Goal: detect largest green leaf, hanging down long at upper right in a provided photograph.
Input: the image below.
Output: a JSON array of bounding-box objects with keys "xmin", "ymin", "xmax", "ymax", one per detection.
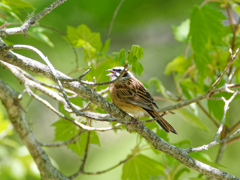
[{"xmin": 190, "ymin": 5, "xmax": 226, "ymax": 79}]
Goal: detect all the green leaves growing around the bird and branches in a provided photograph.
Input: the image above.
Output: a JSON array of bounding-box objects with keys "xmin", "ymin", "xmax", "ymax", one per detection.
[{"xmin": 0, "ymin": 0, "xmax": 240, "ymax": 180}]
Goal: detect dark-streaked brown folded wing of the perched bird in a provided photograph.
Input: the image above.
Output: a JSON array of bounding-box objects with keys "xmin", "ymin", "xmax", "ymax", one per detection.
[{"xmin": 115, "ymin": 78, "xmax": 158, "ymax": 110}]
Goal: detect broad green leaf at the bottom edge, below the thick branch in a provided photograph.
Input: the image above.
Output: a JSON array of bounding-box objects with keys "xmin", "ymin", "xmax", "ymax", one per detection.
[{"xmin": 122, "ymin": 154, "xmax": 164, "ymax": 180}]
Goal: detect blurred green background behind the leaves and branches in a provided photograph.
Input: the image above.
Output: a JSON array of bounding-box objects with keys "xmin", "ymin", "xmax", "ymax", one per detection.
[{"xmin": 0, "ymin": 0, "xmax": 240, "ymax": 180}]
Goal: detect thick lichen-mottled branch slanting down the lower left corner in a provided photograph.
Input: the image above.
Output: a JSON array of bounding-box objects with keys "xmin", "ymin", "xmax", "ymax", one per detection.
[{"xmin": 0, "ymin": 80, "xmax": 68, "ymax": 180}]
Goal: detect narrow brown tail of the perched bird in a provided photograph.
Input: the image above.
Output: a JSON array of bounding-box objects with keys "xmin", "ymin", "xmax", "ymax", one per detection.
[{"xmin": 144, "ymin": 109, "xmax": 177, "ymax": 134}]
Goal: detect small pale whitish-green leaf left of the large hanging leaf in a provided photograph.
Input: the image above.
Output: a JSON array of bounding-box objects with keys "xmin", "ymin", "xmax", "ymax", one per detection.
[{"xmin": 172, "ymin": 19, "xmax": 190, "ymax": 42}]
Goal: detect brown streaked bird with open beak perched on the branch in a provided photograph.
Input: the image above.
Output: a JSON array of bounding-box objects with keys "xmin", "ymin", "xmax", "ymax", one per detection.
[{"xmin": 106, "ymin": 66, "xmax": 177, "ymax": 134}]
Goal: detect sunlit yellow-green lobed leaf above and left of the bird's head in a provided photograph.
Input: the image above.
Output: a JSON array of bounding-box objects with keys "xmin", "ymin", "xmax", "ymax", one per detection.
[{"xmin": 67, "ymin": 24, "xmax": 102, "ymax": 50}]
